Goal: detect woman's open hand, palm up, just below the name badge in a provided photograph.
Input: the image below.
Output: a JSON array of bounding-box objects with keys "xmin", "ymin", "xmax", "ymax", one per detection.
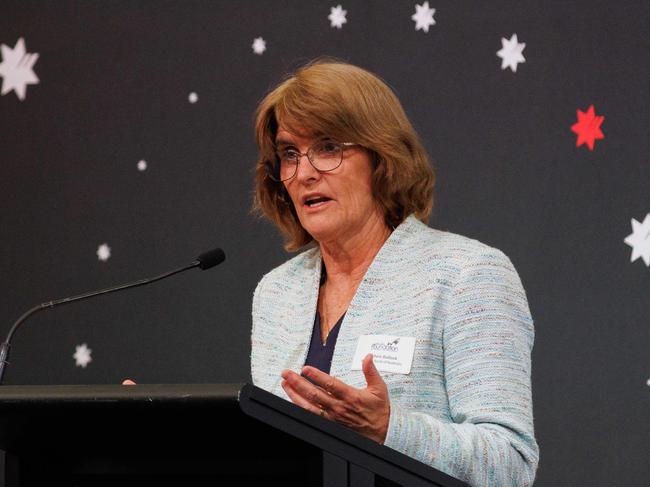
[{"xmin": 282, "ymin": 354, "xmax": 390, "ymax": 443}]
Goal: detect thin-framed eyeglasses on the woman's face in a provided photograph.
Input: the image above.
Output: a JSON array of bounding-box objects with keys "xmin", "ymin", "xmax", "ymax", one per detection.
[{"xmin": 266, "ymin": 140, "xmax": 358, "ymax": 183}]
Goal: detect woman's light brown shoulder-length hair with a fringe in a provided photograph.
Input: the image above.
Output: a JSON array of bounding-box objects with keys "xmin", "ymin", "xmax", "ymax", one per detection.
[{"xmin": 253, "ymin": 59, "xmax": 436, "ymax": 251}]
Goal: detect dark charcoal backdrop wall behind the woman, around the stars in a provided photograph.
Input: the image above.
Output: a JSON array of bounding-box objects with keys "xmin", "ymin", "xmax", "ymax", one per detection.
[{"xmin": 0, "ymin": 0, "xmax": 650, "ymax": 486}]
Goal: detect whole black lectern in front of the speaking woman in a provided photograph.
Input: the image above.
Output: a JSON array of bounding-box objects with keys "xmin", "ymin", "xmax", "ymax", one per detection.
[{"xmin": 0, "ymin": 384, "xmax": 465, "ymax": 487}]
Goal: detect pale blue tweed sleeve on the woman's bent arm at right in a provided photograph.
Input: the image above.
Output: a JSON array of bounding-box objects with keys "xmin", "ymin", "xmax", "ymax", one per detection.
[{"xmin": 384, "ymin": 248, "xmax": 539, "ymax": 487}]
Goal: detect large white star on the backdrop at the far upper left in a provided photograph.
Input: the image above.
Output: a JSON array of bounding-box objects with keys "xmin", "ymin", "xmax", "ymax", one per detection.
[{"xmin": 0, "ymin": 37, "xmax": 39, "ymax": 101}]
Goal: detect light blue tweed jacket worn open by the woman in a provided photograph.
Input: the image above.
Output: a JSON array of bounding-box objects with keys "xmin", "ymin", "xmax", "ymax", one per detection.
[{"xmin": 251, "ymin": 216, "xmax": 539, "ymax": 487}]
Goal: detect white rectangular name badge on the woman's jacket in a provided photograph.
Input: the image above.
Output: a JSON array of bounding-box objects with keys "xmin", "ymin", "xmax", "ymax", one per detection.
[{"xmin": 352, "ymin": 335, "xmax": 415, "ymax": 374}]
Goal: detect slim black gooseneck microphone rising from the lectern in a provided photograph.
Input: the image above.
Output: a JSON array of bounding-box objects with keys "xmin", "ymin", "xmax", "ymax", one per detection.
[{"xmin": 0, "ymin": 248, "xmax": 226, "ymax": 385}]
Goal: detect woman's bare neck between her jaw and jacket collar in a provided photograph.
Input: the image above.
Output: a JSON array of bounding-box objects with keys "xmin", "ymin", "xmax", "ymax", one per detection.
[{"xmin": 319, "ymin": 215, "xmax": 391, "ymax": 283}]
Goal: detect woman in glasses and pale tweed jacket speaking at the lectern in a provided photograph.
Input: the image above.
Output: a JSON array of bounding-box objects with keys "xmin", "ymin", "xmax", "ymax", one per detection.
[{"xmin": 251, "ymin": 61, "xmax": 539, "ymax": 486}]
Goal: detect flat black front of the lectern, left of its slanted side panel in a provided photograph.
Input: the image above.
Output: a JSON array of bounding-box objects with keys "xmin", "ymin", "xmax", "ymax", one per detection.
[{"xmin": 0, "ymin": 384, "xmax": 322, "ymax": 487}]
